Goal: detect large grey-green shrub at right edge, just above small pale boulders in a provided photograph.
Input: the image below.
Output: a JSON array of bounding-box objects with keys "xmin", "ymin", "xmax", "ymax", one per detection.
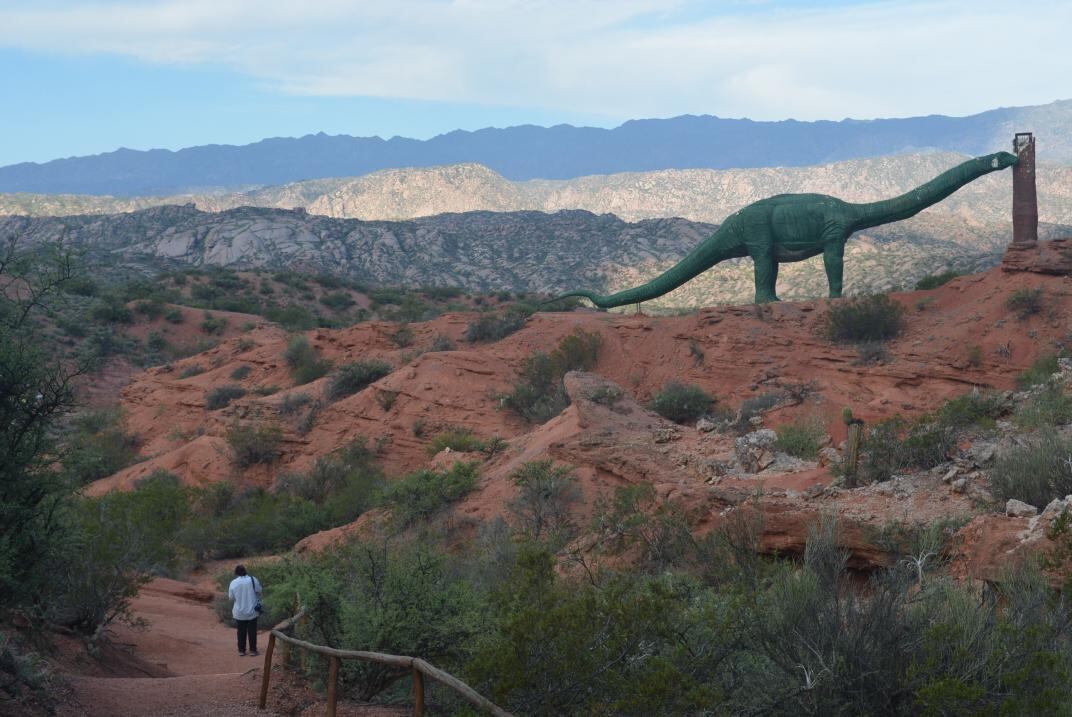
[{"xmin": 991, "ymin": 431, "xmax": 1072, "ymax": 510}]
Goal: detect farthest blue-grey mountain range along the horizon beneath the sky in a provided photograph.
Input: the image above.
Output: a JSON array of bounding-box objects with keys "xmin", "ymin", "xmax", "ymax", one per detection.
[{"xmin": 6, "ymin": 100, "xmax": 1072, "ymax": 196}]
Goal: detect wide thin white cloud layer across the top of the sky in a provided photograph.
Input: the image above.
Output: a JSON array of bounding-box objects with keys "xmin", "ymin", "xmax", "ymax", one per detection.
[{"xmin": 0, "ymin": 0, "xmax": 1072, "ymax": 119}]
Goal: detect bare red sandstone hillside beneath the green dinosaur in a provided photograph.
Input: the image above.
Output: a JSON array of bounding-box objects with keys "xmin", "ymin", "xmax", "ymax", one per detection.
[{"xmin": 89, "ymin": 262, "xmax": 1069, "ymax": 577}]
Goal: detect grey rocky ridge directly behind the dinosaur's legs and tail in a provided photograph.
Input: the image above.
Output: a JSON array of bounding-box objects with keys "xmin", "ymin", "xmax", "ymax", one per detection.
[{"xmin": 6, "ymin": 201, "xmax": 1072, "ymax": 307}]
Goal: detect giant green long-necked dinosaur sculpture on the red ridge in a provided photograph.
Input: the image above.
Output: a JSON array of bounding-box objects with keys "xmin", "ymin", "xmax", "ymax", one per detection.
[{"xmin": 555, "ymin": 152, "xmax": 1017, "ymax": 309}]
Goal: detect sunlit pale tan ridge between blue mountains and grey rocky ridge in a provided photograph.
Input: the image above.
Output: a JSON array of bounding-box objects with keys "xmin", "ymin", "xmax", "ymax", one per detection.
[{"xmin": 6, "ymin": 152, "xmax": 1072, "ymax": 230}]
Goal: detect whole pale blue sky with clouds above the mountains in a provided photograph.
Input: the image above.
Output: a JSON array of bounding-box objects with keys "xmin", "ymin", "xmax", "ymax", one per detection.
[{"xmin": 0, "ymin": 0, "xmax": 1072, "ymax": 165}]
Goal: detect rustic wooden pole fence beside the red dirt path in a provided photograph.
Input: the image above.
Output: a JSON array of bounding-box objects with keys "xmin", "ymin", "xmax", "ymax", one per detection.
[{"xmin": 257, "ymin": 608, "xmax": 513, "ymax": 717}]
